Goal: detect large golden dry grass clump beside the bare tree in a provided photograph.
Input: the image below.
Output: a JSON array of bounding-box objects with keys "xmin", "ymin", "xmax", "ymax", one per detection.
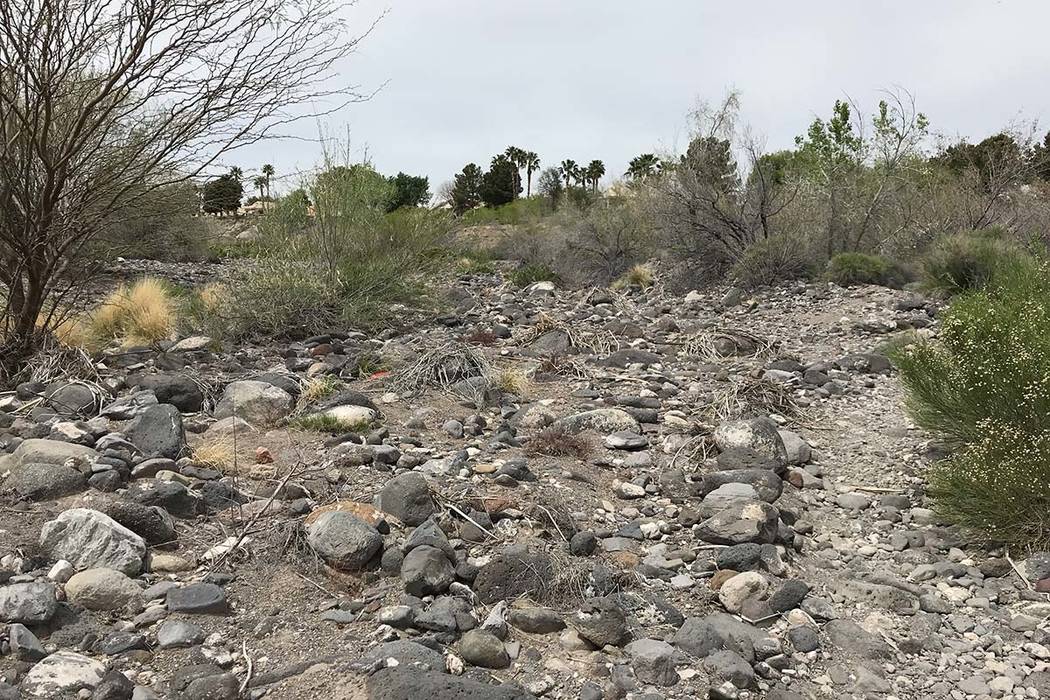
[{"xmin": 88, "ymin": 277, "xmax": 177, "ymax": 345}]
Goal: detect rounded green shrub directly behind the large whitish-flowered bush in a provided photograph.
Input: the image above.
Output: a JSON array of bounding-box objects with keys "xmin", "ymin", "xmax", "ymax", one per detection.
[{"xmin": 922, "ymin": 229, "xmax": 1035, "ymax": 295}]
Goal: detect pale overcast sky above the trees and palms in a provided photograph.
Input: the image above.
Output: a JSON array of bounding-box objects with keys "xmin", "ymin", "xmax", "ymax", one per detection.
[{"xmin": 235, "ymin": 0, "xmax": 1050, "ymax": 191}]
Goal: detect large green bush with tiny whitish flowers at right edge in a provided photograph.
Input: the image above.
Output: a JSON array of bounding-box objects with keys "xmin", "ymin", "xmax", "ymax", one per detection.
[{"xmin": 893, "ymin": 261, "xmax": 1050, "ymax": 546}]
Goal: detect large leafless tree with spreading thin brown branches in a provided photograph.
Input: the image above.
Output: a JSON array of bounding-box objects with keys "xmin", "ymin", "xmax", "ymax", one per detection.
[{"xmin": 0, "ymin": 0, "xmax": 374, "ymax": 372}]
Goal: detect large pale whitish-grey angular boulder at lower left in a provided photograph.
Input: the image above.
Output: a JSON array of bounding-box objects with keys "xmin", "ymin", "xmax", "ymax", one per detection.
[{"xmin": 40, "ymin": 508, "xmax": 146, "ymax": 576}]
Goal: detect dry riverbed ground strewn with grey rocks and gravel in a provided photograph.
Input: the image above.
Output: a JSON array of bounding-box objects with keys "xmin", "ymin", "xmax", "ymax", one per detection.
[{"xmin": 0, "ymin": 264, "xmax": 1050, "ymax": 700}]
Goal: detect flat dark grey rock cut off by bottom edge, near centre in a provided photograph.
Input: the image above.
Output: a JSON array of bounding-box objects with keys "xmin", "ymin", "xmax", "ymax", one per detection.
[{"xmin": 368, "ymin": 666, "xmax": 533, "ymax": 700}]
